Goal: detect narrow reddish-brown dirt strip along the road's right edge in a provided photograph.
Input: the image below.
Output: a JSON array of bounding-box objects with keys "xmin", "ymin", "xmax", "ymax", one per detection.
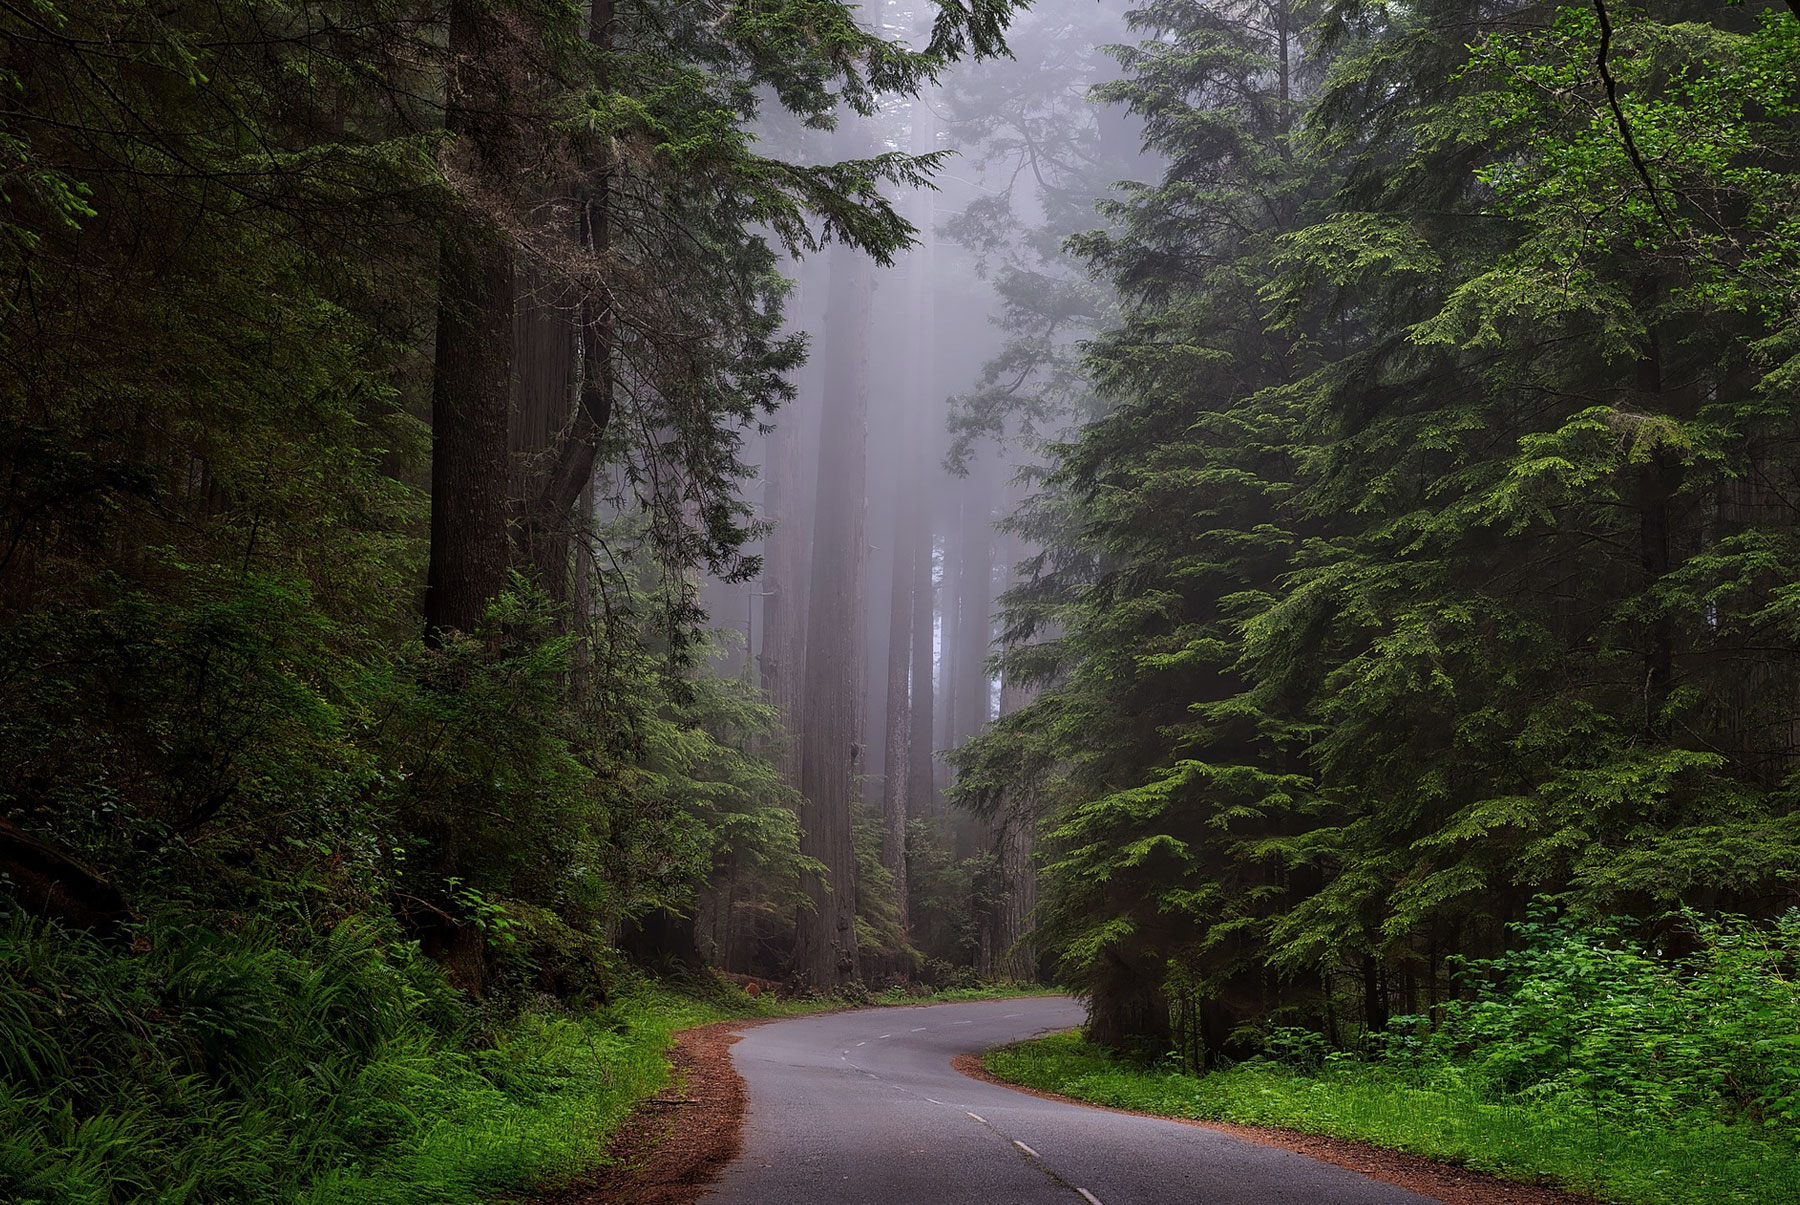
[{"xmin": 950, "ymin": 1054, "xmax": 1597, "ymax": 1205}]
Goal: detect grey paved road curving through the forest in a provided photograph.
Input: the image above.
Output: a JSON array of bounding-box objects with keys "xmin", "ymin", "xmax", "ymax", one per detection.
[{"xmin": 702, "ymin": 998, "xmax": 1431, "ymax": 1205}]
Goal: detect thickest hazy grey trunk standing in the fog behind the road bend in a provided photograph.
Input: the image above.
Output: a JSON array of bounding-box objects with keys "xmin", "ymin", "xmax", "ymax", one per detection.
[{"xmin": 794, "ymin": 239, "xmax": 873, "ymax": 989}]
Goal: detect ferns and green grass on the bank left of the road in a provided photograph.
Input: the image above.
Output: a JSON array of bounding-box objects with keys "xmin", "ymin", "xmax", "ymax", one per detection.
[{"xmin": 0, "ymin": 910, "xmax": 745, "ymax": 1205}]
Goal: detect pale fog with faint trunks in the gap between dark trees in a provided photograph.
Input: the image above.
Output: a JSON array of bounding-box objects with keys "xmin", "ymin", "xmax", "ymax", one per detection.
[{"xmin": 680, "ymin": 0, "xmax": 1152, "ymax": 983}]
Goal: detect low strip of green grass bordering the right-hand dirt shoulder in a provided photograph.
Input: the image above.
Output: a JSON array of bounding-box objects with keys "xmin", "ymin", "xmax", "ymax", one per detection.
[{"xmin": 985, "ymin": 1034, "xmax": 1800, "ymax": 1205}]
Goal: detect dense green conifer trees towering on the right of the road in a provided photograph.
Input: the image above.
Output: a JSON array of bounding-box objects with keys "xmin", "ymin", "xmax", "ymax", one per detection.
[{"xmin": 956, "ymin": 2, "xmax": 1800, "ymax": 1057}]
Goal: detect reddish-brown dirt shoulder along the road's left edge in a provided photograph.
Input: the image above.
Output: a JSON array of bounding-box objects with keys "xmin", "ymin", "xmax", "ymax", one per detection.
[{"xmin": 538, "ymin": 1019, "xmax": 763, "ymax": 1205}]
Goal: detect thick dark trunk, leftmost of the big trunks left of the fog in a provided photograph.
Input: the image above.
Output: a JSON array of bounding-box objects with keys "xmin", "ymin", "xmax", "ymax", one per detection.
[{"xmin": 425, "ymin": 0, "xmax": 513, "ymax": 639}]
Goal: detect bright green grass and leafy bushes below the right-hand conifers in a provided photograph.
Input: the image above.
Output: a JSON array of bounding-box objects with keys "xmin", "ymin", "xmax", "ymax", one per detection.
[{"xmin": 986, "ymin": 908, "xmax": 1800, "ymax": 1203}]
